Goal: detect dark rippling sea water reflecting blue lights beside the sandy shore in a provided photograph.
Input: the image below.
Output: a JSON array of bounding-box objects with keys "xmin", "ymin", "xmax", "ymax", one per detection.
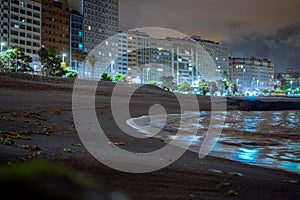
[{"xmin": 128, "ymin": 110, "xmax": 300, "ymax": 173}]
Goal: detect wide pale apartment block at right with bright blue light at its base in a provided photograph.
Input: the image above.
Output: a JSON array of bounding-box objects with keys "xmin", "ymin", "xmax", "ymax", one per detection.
[{"xmin": 229, "ymin": 57, "xmax": 274, "ymax": 93}]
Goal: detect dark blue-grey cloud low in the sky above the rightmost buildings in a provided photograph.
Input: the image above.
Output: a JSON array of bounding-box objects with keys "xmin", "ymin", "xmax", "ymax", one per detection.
[{"xmin": 224, "ymin": 24, "xmax": 300, "ymax": 72}]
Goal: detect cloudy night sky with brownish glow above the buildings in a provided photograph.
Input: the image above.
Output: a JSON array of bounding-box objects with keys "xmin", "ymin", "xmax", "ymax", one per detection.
[{"xmin": 71, "ymin": 0, "xmax": 300, "ymax": 72}]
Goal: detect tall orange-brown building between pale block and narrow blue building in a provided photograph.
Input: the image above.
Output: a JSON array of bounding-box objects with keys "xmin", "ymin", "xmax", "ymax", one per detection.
[{"xmin": 42, "ymin": 0, "xmax": 70, "ymax": 65}]
